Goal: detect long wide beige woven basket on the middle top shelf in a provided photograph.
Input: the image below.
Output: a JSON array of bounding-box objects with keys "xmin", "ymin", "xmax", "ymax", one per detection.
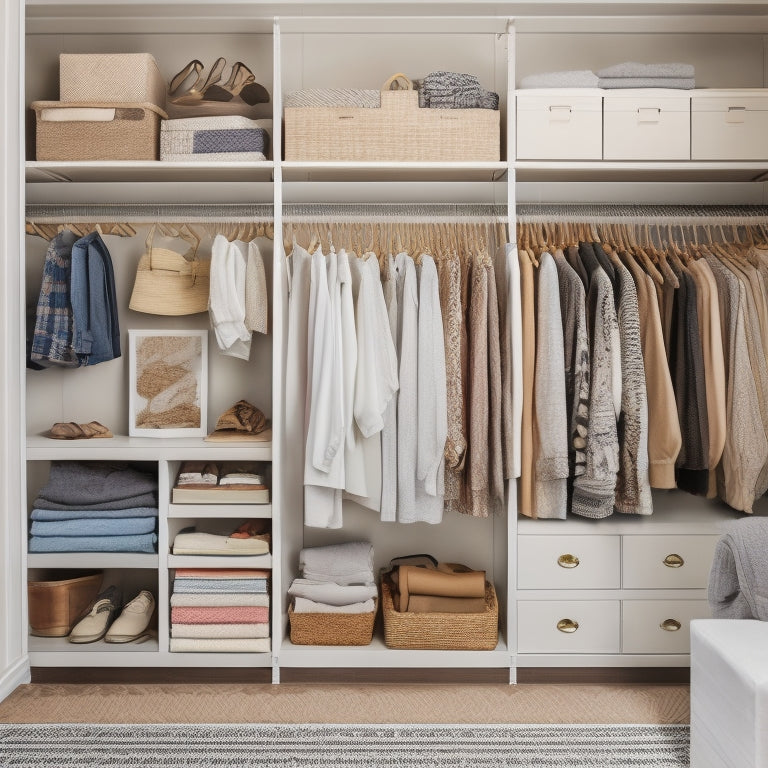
[{"xmin": 285, "ymin": 73, "xmax": 501, "ymax": 162}]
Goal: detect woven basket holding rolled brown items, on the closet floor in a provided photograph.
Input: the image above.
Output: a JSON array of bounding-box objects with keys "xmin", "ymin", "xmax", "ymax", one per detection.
[{"xmin": 381, "ymin": 576, "xmax": 499, "ymax": 651}]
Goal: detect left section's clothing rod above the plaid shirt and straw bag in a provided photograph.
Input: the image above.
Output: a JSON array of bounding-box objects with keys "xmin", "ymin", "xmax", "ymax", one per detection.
[{"xmin": 25, "ymin": 203, "xmax": 274, "ymax": 224}]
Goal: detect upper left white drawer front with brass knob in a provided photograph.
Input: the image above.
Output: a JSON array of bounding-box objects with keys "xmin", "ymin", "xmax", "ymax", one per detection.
[{"xmin": 517, "ymin": 536, "xmax": 621, "ymax": 589}]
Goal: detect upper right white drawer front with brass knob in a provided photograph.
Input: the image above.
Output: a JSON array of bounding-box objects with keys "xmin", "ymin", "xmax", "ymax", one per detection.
[{"xmin": 622, "ymin": 535, "xmax": 720, "ymax": 589}]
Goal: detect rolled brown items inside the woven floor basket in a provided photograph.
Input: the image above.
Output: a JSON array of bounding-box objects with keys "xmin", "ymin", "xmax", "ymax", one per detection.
[{"xmin": 388, "ymin": 555, "xmax": 486, "ymax": 613}]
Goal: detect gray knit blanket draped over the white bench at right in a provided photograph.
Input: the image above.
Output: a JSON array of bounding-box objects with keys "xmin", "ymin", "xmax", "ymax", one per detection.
[{"xmin": 709, "ymin": 517, "xmax": 768, "ymax": 621}]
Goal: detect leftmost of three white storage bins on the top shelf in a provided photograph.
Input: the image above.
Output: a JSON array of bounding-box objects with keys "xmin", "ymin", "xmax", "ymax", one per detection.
[{"xmin": 517, "ymin": 88, "xmax": 603, "ymax": 160}]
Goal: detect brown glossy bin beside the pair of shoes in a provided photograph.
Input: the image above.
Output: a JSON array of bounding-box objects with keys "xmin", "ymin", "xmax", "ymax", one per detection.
[{"xmin": 27, "ymin": 573, "xmax": 103, "ymax": 637}]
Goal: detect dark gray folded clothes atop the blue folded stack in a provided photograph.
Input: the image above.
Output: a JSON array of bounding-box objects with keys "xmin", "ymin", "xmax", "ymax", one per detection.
[{"xmin": 35, "ymin": 461, "xmax": 157, "ymax": 507}]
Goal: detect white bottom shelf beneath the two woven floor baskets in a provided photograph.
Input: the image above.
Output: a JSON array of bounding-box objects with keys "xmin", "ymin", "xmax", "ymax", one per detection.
[{"xmin": 279, "ymin": 635, "xmax": 509, "ymax": 669}]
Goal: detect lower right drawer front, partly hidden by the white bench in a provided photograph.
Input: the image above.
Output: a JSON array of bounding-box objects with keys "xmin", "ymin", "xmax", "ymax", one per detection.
[{"xmin": 621, "ymin": 600, "xmax": 711, "ymax": 653}]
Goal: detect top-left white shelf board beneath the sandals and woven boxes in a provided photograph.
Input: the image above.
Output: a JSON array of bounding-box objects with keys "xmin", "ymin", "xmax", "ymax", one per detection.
[{"xmin": 25, "ymin": 160, "xmax": 275, "ymax": 183}]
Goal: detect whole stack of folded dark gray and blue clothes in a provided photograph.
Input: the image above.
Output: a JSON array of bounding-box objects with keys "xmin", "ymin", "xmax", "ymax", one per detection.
[{"xmin": 29, "ymin": 461, "xmax": 157, "ymax": 553}]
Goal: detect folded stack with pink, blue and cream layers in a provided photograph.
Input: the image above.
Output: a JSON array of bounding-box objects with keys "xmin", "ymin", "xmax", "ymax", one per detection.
[{"xmin": 170, "ymin": 568, "xmax": 270, "ymax": 653}]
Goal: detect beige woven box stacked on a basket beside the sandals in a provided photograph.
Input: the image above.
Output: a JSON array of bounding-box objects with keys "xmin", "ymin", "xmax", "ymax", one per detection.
[{"xmin": 59, "ymin": 53, "xmax": 166, "ymax": 109}]
